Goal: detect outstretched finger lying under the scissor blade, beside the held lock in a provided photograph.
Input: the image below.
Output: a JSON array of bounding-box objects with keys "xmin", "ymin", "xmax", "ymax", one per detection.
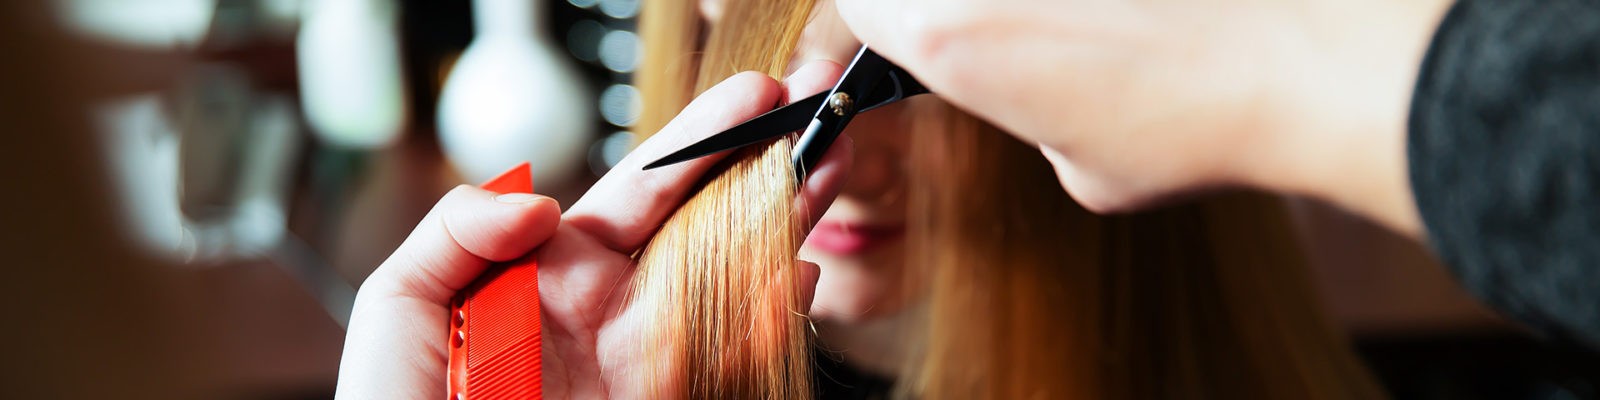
[{"xmin": 565, "ymin": 72, "xmax": 782, "ymax": 253}]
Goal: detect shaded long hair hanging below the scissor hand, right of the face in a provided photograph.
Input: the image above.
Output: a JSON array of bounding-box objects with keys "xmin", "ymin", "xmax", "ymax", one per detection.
[{"xmin": 898, "ymin": 102, "xmax": 1382, "ymax": 398}]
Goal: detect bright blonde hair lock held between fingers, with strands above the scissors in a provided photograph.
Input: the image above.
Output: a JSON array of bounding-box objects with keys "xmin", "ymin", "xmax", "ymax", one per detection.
[{"xmin": 632, "ymin": 0, "xmax": 811, "ymax": 398}]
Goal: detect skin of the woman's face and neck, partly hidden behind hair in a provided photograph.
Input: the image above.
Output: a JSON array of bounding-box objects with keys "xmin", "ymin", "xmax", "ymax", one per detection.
[{"xmin": 774, "ymin": 0, "xmax": 933, "ymax": 376}]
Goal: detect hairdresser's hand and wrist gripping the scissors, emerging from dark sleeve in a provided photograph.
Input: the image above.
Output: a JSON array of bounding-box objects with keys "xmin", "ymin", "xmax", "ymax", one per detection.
[{"xmin": 838, "ymin": 0, "xmax": 1451, "ymax": 230}]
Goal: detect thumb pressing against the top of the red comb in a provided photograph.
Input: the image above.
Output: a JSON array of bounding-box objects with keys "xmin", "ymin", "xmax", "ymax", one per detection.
[{"xmin": 362, "ymin": 186, "xmax": 562, "ymax": 304}]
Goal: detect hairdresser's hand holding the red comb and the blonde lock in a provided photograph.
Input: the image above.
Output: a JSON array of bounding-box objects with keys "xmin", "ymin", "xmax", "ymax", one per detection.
[{"xmin": 338, "ymin": 62, "xmax": 851, "ymax": 398}]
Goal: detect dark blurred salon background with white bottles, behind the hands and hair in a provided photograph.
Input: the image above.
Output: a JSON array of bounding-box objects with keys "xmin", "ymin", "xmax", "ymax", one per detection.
[{"xmin": 0, "ymin": 0, "xmax": 1600, "ymax": 398}]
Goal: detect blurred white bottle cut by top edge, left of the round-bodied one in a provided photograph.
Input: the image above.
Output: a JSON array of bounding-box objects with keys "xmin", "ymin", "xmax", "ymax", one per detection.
[{"xmin": 296, "ymin": 0, "xmax": 406, "ymax": 149}]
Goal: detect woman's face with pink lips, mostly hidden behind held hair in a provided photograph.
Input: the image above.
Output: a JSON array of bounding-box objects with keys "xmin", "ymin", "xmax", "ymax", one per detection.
[{"xmin": 701, "ymin": 0, "xmax": 909, "ymax": 323}]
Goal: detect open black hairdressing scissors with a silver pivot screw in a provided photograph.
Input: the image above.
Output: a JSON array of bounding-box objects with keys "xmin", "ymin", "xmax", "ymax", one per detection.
[{"xmin": 645, "ymin": 45, "xmax": 928, "ymax": 184}]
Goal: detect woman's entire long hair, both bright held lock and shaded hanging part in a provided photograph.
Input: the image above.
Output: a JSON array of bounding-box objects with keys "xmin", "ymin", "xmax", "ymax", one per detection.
[{"xmin": 635, "ymin": 0, "xmax": 1382, "ymax": 398}]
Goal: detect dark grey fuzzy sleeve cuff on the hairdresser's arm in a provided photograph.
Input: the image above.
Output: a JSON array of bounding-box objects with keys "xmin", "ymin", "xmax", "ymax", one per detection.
[{"xmin": 1406, "ymin": 0, "xmax": 1600, "ymax": 349}]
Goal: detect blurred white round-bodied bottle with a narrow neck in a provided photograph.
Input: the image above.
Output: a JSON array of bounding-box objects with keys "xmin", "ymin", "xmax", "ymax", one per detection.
[{"xmin": 438, "ymin": 0, "xmax": 594, "ymax": 182}]
